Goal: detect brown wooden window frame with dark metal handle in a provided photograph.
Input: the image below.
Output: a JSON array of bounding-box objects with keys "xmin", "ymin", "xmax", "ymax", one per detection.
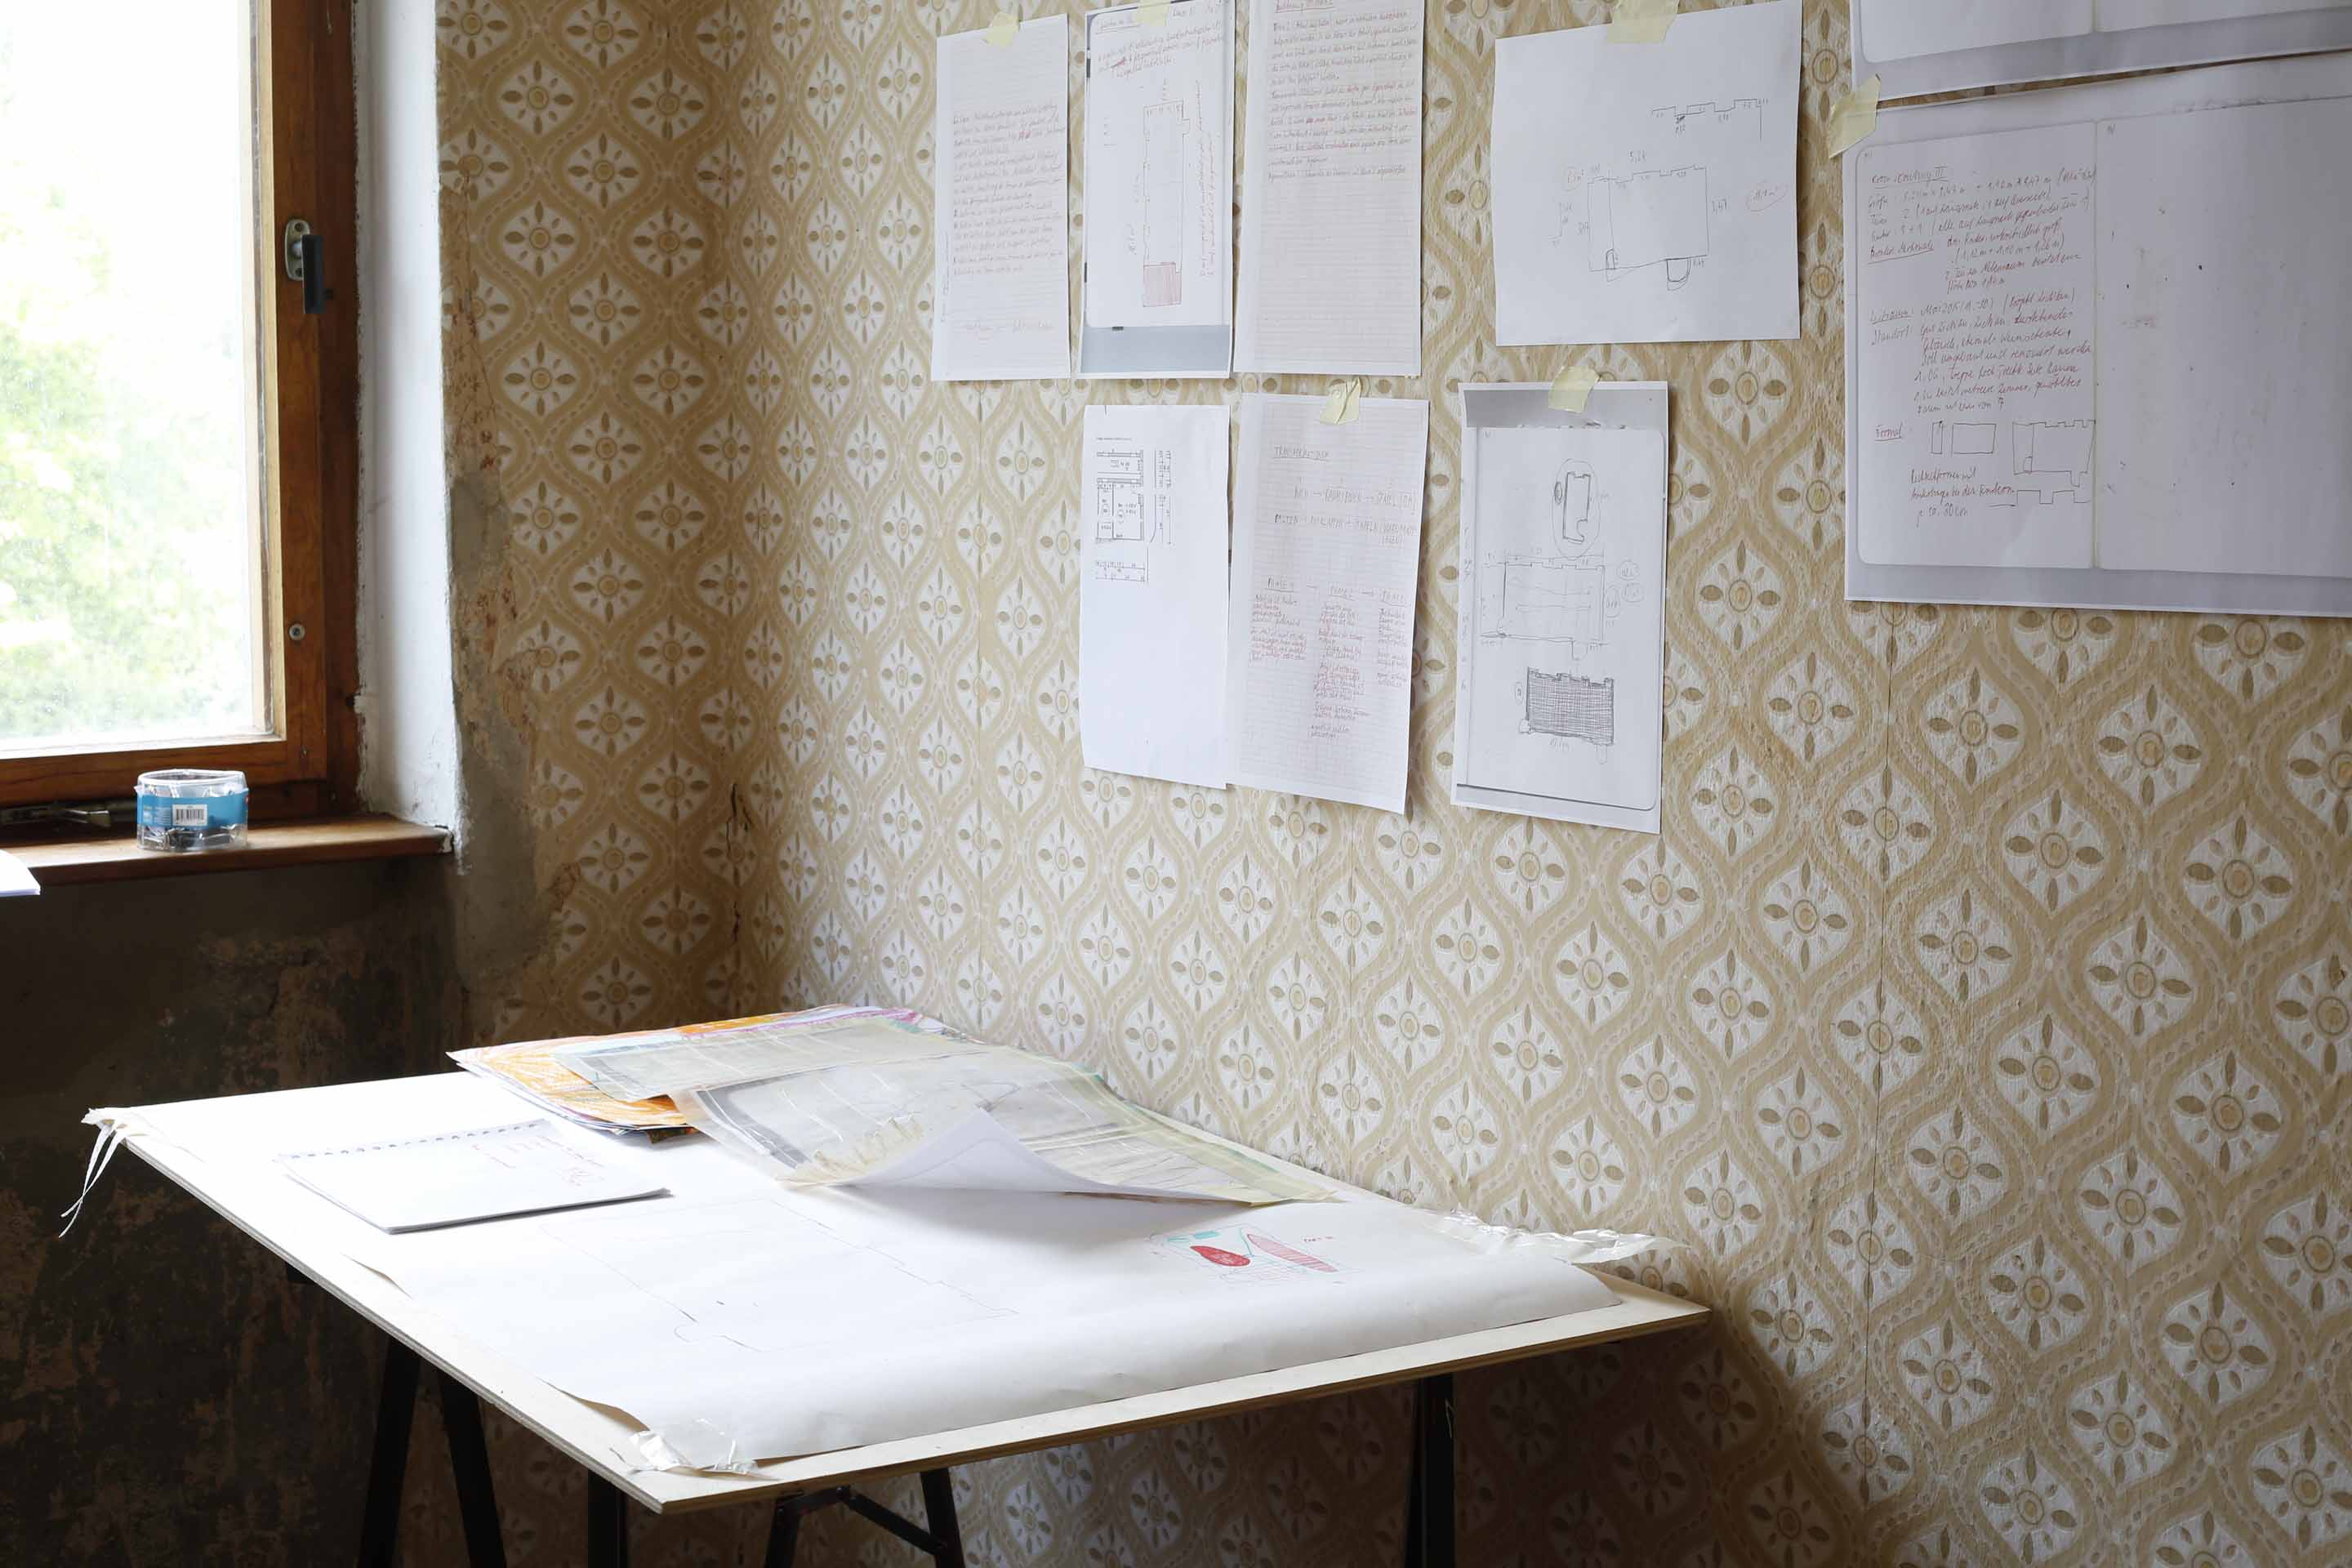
[{"xmin": 0, "ymin": 0, "xmax": 360, "ymax": 821}]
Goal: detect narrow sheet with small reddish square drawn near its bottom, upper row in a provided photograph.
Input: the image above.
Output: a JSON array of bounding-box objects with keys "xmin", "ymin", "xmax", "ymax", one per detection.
[{"xmin": 1085, "ymin": 0, "xmax": 1232, "ymax": 327}]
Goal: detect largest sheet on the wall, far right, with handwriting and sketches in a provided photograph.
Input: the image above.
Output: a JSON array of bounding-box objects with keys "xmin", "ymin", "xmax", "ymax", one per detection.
[{"xmin": 1846, "ymin": 56, "xmax": 2352, "ymax": 613}]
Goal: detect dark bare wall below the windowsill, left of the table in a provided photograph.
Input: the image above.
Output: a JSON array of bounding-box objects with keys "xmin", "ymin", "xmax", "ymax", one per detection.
[{"xmin": 0, "ymin": 862, "xmax": 461, "ymax": 1563}]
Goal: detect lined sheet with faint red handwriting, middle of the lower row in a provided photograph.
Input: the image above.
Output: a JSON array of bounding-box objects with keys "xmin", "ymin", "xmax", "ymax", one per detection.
[{"xmin": 1225, "ymin": 393, "xmax": 1430, "ymax": 811}]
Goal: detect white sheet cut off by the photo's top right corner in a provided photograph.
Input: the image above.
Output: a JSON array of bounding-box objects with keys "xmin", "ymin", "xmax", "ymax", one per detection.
[{"xmin": 1853, "ymin": 0, "xmax": 2352, "ymax": 99}]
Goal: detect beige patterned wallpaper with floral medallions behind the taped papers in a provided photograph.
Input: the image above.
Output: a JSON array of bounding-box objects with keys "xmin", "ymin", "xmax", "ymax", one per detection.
[{"xmin": 432, "ymin": 0, "xmax": 2352, "ymax": 1568}]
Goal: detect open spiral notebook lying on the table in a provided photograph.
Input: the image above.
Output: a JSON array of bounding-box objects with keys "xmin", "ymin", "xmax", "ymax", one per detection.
[{"xmin": 278, "ymin": 1121, "xmax": 668, "ymax": 1232}]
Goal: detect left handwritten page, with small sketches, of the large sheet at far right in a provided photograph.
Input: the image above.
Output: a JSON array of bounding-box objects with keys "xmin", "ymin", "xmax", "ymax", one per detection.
[{"xmin": 1849, "ymin": 125, "xmax": 2098, "ymax": 567}]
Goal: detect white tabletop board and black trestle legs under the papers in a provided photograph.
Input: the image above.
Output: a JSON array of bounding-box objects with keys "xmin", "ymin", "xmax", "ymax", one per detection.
[{"xmin": 100, "ymin": 1072, "xmax": 1708, "ymax": 1568}]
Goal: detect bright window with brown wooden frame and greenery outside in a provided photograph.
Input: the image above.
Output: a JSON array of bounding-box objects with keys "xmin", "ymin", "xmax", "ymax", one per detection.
[{"xmin": 0, "ymin": 0, "xmax": 358, "ymax": 816}]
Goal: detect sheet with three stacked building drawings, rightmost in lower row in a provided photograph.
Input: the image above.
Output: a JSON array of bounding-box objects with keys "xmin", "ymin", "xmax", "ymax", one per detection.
[{"xmin": 1454, "ymin": 416, "xmax": 1665, "ymax": 825}]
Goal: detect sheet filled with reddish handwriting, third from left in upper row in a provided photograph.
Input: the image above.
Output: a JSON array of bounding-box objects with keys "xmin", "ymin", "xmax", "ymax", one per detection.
[{"xmin": 1235, "ymin": 0, "xmax": 1423, "ymax": 376}]
